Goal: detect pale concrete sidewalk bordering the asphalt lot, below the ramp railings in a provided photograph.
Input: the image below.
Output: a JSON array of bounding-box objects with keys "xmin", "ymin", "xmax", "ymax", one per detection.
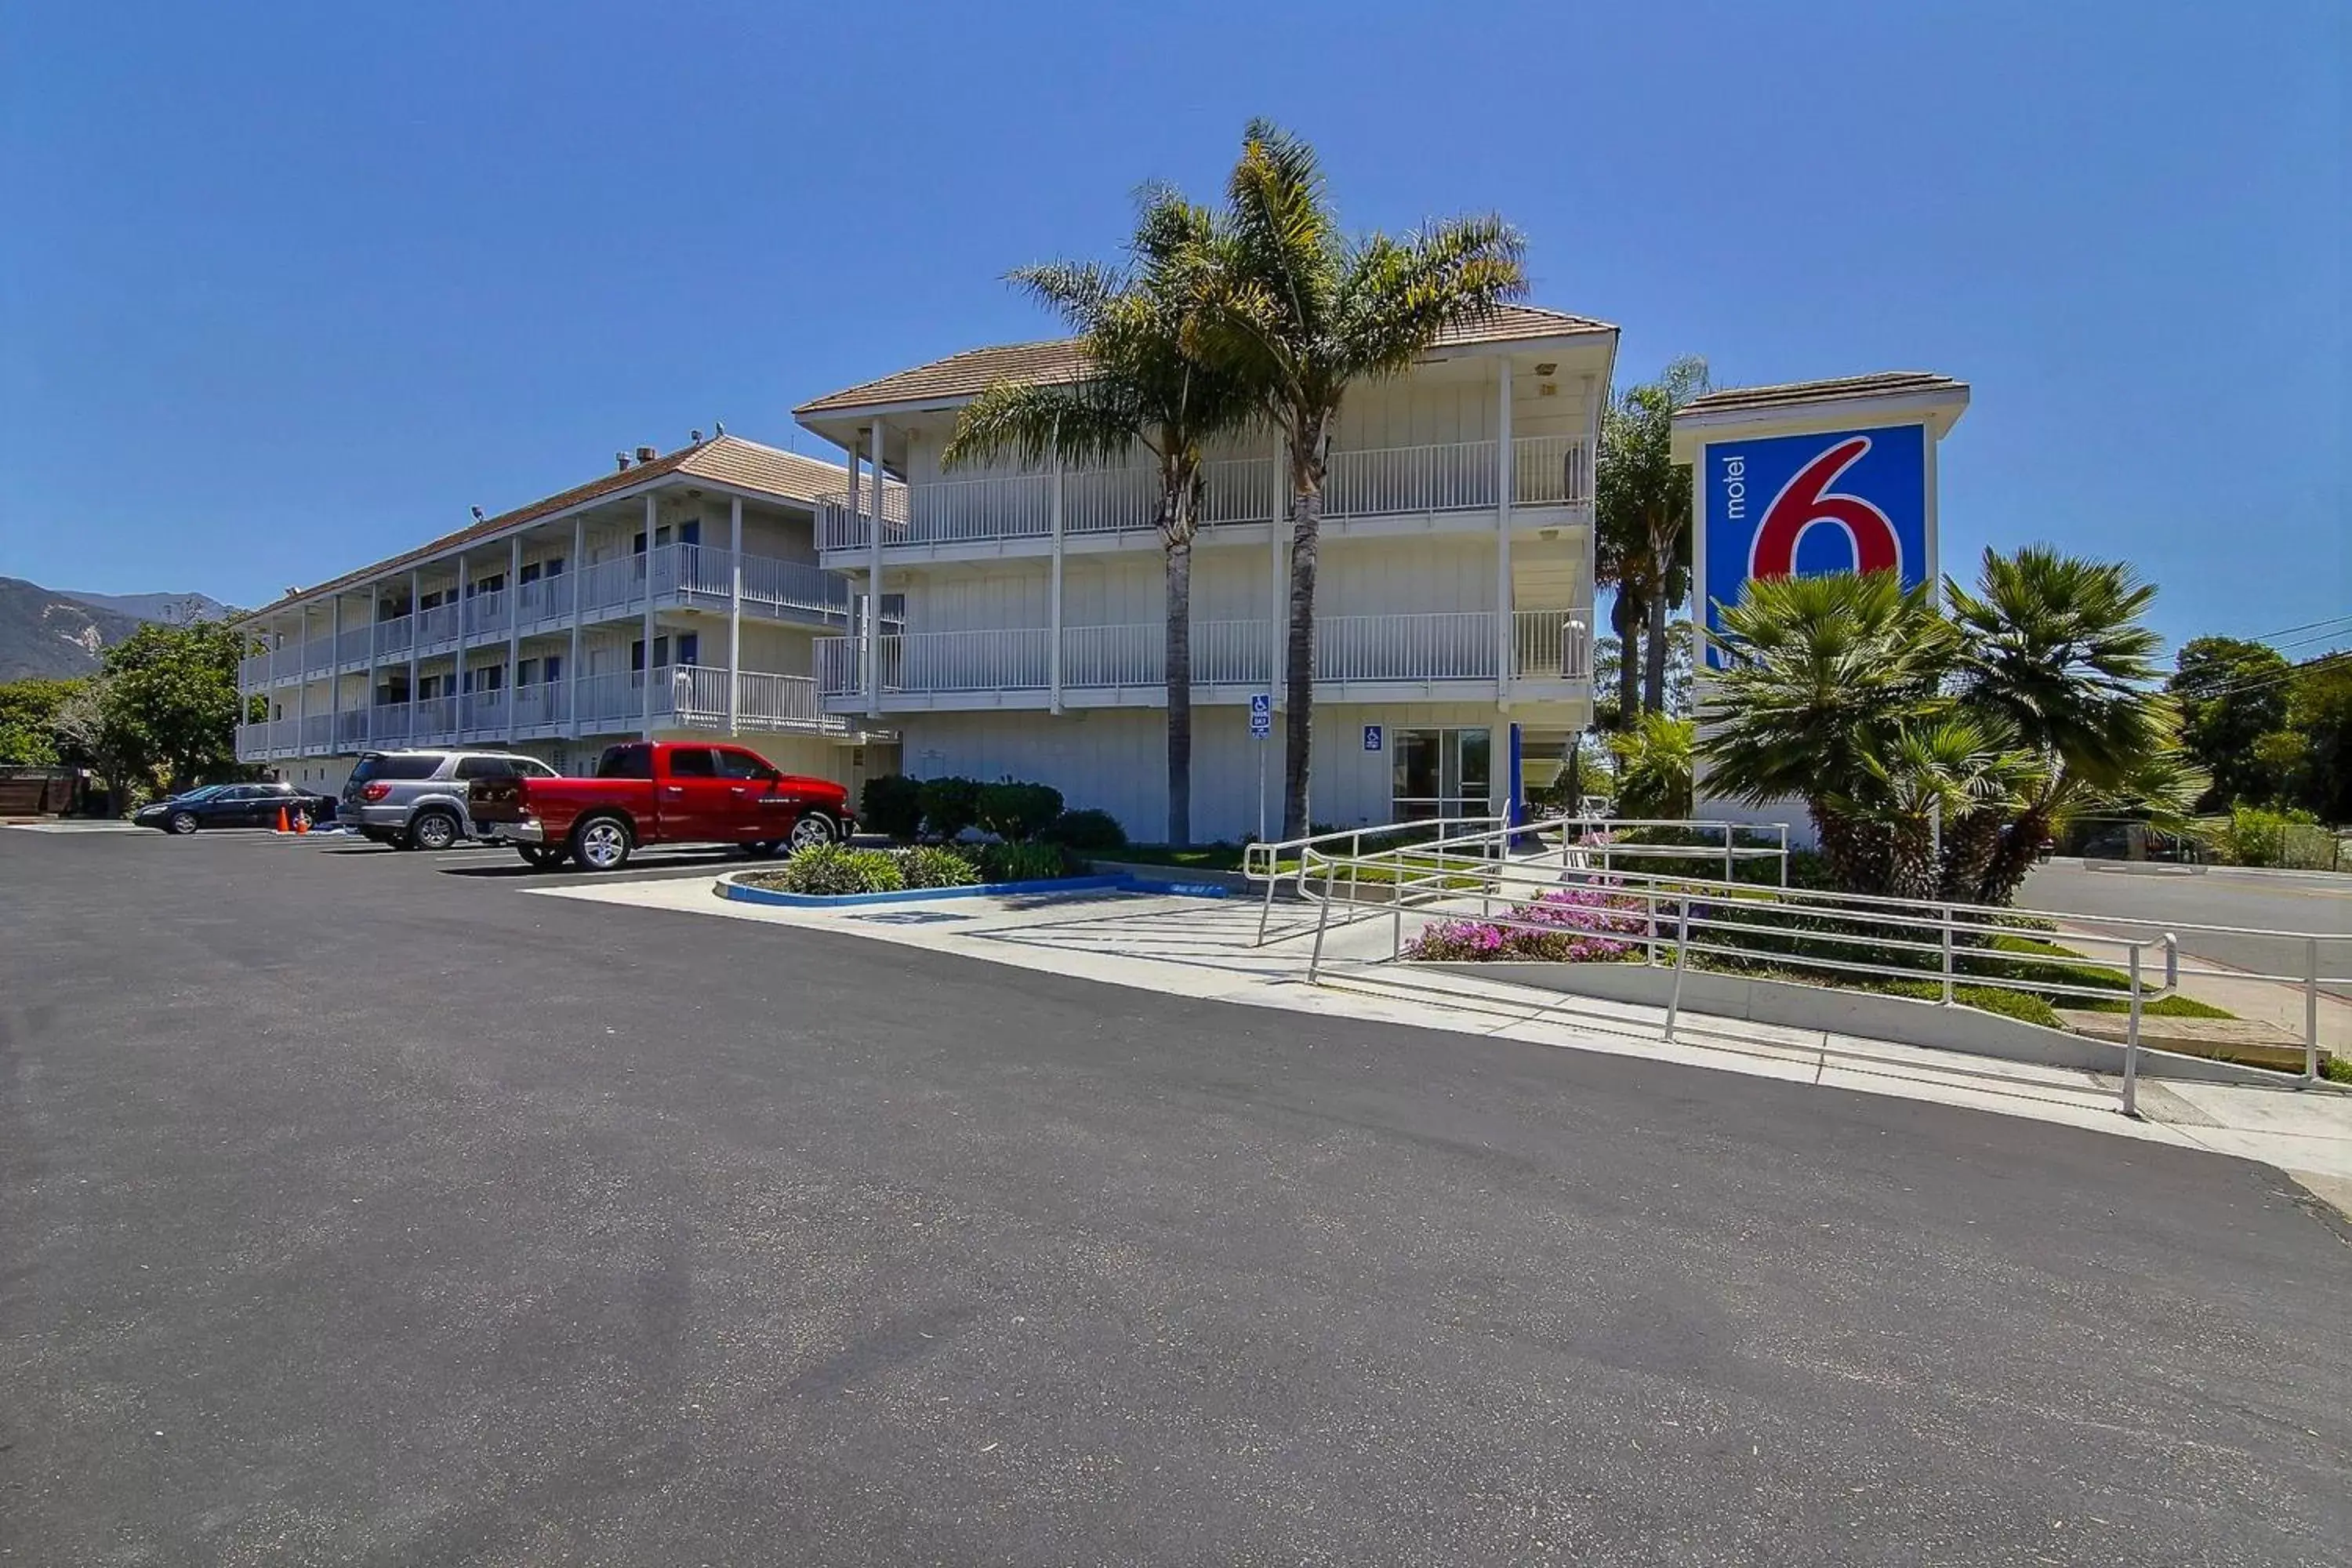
[{"xmin": 532, "ymin": 877, "xmax": 2352, "ymax": 1213}]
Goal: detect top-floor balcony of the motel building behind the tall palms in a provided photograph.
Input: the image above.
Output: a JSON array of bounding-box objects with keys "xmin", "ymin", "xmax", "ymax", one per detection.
[{"xmin": 816, "ymin": 435, "xmax": 1592, "ymax": 572}]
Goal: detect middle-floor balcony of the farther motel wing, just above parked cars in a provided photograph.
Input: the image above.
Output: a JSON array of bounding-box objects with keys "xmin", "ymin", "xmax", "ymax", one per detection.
[{"xmin": 238, "ymin": 666, "xmax": 851, "ymax": 762}]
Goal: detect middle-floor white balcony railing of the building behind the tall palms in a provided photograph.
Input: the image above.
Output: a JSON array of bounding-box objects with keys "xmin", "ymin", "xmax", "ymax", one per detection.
[{"xmin": 816, "ymin": 609, "xmax": 1590, "ymax": 699}]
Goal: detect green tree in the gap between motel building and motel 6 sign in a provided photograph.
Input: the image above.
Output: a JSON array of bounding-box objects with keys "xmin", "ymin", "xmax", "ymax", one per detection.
[{"xmin": 1592, "ymin": 355, "xmax": 1708, "ymax": 729}]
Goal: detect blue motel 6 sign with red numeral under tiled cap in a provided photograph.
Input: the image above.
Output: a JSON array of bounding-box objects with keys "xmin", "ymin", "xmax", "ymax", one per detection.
[{"xmin": 1675, "ymin": 376, "xmax": 1969, "ymax": 670}]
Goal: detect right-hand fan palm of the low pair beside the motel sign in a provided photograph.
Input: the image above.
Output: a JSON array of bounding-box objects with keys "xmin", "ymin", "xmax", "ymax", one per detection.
[{"xmin": 1945, "ymin": 546, "xmax": 2190, "ymax": 902}]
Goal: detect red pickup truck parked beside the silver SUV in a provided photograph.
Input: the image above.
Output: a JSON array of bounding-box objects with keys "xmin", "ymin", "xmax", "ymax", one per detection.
[{"xmin": 466, "ymin": 741, "xmax": 856, "ymax": 872}]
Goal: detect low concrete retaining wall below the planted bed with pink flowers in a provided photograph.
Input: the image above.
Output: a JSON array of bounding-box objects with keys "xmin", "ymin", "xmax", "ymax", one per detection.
[{"xmin": 1428, "ymin": 964, "xmax": 2286, "ymax": 1086}]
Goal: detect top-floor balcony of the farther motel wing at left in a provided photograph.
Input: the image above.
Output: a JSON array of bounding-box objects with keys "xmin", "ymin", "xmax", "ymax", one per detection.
[{"xmin": 238, "ymin": 546, "xmax": 849, "ymax": 691}]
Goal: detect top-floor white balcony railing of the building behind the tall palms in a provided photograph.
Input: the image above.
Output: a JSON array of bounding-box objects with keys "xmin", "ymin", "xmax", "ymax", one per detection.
[{"xmin": 818, "ymin": 435, "xmax": 1592, "ymax": 550}]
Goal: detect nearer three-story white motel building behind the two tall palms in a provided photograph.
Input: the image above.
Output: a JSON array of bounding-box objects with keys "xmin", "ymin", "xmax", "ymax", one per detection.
[{"xmin": 795, "ymin": 306, "xmax": 1616, "ymax": 839}]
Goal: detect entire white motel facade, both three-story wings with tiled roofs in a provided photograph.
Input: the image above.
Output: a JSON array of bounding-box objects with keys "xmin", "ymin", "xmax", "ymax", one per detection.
[{"xmin": 238, "ymin": 306, "xmax": 1618, "ymax": 841}]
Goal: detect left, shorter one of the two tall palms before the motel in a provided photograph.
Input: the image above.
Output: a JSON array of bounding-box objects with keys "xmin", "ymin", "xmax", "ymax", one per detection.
[{"xmin": 941, "ymin": 191, "xmax": 1256, "ymax": 860}]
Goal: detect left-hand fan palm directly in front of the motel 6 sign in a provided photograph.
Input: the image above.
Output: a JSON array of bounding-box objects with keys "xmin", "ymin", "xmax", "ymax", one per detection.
[{"xmin": 1698, "ymin": 572, "xmax": 1957, "ymax": 893}]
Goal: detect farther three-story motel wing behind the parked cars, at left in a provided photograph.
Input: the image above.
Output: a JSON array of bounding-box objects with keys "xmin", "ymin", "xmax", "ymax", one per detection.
[{"xmin": 238, "ymin": 433, "xmax": 896, "ymax": 789}]
